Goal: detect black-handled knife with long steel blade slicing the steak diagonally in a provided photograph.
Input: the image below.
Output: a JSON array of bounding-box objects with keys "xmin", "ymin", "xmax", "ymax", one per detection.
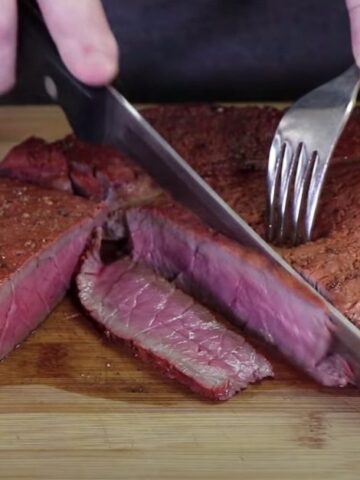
[{"xmin": 18, "ymin": 0, "xmax": 360, "ymax": 386}]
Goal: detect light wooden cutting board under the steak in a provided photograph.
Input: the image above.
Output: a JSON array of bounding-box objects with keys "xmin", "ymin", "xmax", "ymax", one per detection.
[{"xmin": 0, "ymin": 107, "xmax": 360, "ymax": 480}]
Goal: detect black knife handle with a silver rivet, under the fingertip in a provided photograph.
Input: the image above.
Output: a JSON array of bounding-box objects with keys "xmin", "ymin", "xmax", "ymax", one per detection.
[{"xmin": 17, "ymin": 0, "xmax": 101, "ymax": 137}]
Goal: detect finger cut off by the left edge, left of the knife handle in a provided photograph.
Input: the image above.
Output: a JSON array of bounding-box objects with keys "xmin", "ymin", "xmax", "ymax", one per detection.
[{"xmin": 0, "ymin": 0, "xmax": 17, "ymax": 93}]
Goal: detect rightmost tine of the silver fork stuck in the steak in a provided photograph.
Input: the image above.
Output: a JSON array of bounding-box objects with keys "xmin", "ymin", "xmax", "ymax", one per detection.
[{"xmin": 305, "ymin": 152, "xmax": 328, "ymax": 241}]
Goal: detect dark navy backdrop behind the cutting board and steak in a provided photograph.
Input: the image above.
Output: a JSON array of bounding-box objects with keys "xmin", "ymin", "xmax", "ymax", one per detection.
[{"xmin": 2, "ymin": 0, "xmax": 353, "ymax": 103}]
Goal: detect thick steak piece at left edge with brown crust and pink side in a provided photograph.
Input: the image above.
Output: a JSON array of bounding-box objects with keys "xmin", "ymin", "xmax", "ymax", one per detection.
[{"xmin": 0, "ymin": 179, "xmax": 104, "ymax": 359}]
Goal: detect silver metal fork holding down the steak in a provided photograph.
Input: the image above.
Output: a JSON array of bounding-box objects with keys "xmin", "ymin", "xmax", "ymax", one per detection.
[{"xmin": 267, "ymin": 65, "xmax": 360, "ymax": 245}]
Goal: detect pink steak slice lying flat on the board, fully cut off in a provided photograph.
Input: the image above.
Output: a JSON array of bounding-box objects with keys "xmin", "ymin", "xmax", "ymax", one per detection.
[{"xmin": 76, "ymin": 231, "xmax": 272, "ymax": 400}]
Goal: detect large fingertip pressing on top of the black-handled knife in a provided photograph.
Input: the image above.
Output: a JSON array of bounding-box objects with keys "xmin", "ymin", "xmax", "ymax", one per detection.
[{"xmin": 38, "ymin": 0, "xmax": 119, "ymax": 86}]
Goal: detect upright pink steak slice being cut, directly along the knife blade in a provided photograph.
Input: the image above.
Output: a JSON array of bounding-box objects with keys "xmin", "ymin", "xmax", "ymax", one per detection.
[{"xmin": 127, "ymin": 203, "xmax": 353, "ymax": 386}]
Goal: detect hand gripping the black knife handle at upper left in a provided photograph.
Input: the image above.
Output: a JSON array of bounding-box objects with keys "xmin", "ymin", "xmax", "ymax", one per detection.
[{"xmin": 0, "ymin": 0, "xmax": 118, "ymax": 93}]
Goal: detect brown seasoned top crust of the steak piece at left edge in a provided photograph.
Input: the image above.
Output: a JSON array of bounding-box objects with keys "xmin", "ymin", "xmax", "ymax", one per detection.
[{"xmin": 0, "ymin": 178, "xmax": 103, "ymax": 287}]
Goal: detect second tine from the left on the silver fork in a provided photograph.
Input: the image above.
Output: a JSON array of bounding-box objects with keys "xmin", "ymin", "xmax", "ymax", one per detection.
[{"xmin": 276, "ymin": 141, "xmax": 296, "ymax": 243}]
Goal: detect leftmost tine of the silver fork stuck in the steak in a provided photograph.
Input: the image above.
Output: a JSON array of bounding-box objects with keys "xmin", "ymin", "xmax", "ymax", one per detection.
[{"xmin": 267, "ymin": 135, "xmax": 283, "ymax": 242}]
